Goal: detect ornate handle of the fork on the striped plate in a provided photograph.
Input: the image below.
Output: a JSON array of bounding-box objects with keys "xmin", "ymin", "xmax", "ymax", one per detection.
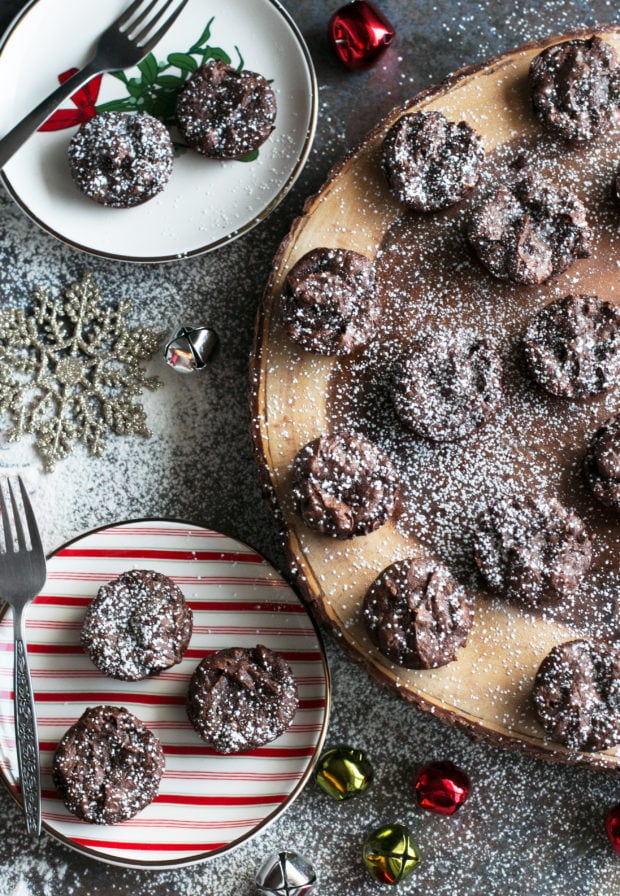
[{"xmin": 13, "ymin": 612, "xmax": 41, "ymax": 837}]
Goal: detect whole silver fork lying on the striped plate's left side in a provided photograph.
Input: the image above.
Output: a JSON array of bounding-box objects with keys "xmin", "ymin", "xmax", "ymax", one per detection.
[{"xmin": 0, "ymin": 477, "xmax": 46, "ymax": 837}]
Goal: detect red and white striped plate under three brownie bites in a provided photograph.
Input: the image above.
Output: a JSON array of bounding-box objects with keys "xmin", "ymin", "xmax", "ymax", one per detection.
[{"xmin": 0, "ymin": 520, "xmax": 329, "ymax": 868}]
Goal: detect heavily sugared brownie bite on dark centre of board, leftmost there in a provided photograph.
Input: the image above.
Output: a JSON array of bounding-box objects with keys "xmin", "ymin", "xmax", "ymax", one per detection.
[{"xmin": 392, "ymin": 329, "xmax": 502, "ymax": 442}]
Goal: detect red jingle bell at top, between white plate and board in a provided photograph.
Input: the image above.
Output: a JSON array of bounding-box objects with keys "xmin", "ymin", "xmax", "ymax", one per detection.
[{"xmin": 328, "ymin": 0, "xmax": 396, "ymax": 69}]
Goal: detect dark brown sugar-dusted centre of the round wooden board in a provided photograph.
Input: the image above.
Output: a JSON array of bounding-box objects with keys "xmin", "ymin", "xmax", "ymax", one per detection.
[{"xmin": 328, "ymin": 122, "xmax": 620, "ymax": 636}]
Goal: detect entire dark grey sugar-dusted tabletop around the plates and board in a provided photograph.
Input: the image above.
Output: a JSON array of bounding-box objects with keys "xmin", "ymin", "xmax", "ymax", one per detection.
[{"xmin": 0, "ymin": 0, "xmax": 620, "ymax": 896}]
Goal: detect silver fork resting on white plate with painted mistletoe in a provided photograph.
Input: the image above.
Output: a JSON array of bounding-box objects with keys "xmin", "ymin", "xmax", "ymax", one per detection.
[{"xmin": 0, "ymin": 0, "xmax": 188, "ymax": 169}]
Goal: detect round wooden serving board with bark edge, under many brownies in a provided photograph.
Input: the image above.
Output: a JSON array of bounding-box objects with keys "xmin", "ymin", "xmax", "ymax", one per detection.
[{"xmin": 252, "ymin": 26, "xmax": 620, "ymax": 769}]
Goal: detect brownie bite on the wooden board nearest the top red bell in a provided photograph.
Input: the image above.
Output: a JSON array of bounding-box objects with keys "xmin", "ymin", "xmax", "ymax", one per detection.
[{"xmin": 381, "ymin": 112, "xmax": 484, "ymax": 212}]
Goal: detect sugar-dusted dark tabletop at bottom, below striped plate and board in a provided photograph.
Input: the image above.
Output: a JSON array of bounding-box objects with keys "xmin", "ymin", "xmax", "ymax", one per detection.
[{"xmin": 0, "ymin": 645, "xmax": 620, "ymax": 896}]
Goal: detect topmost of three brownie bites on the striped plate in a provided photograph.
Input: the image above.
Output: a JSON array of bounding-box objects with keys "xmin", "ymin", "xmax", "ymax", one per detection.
[{"xmin": 82, "ymin": 569, "xmax": 192, "ymax": 681}]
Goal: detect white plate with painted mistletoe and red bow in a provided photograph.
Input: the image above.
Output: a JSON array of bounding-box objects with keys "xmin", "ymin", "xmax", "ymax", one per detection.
[{"xmin": 0, "ymin": 0, "xmax": 317, "ymax": 262}]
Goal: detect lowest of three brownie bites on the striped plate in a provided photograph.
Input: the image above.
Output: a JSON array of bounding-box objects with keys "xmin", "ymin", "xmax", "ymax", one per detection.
[{"xmin": 52, "ymin": 706, "xmax": 165, "ymax": 824}]
